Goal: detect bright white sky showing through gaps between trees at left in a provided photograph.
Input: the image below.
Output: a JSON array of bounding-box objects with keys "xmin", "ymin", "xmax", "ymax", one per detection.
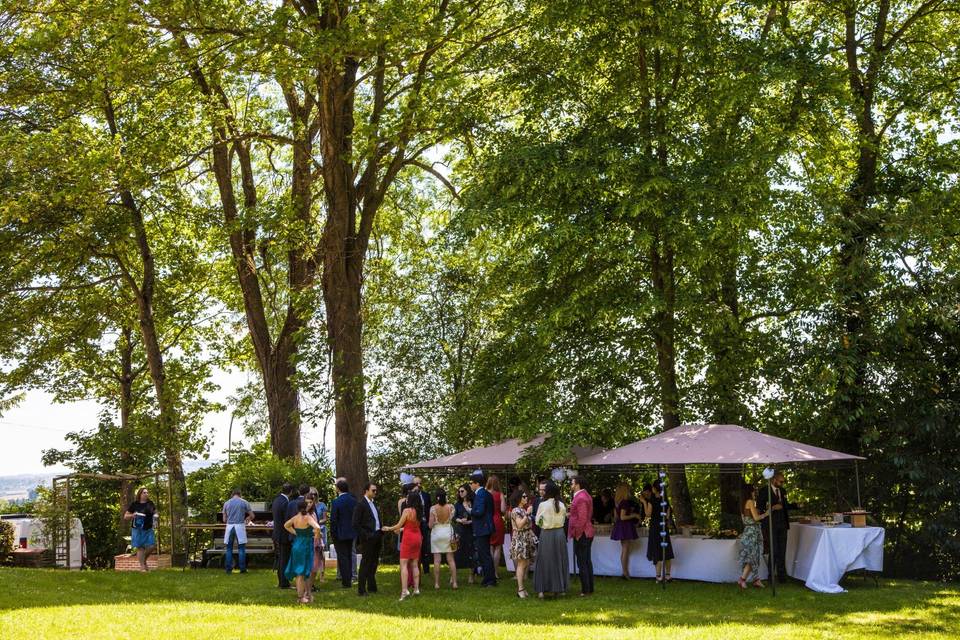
[{"xmin": 0, "ymin": 371, "xmax": 333, "ymax": 476}]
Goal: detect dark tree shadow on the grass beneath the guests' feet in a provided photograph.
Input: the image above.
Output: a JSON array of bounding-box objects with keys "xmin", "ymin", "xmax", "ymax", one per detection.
[{"xmin": 0, "ymin": 566, "xmax": 960, "ymax": 635}]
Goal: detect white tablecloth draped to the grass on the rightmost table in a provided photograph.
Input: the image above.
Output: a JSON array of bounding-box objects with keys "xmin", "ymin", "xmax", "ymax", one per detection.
[{"xmin": 787, "ymin": 524, "xmax": 885, "ymax": 593}]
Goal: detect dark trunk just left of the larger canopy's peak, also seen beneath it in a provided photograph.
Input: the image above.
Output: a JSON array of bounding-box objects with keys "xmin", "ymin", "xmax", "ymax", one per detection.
[{"xmin": 650, "ymin": 235, "xmax": 693, "ymax": 524}]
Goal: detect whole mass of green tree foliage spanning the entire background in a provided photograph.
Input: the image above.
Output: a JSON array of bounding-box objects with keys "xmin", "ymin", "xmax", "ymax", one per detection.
[{"xmin": 0, "ymin": 0, "xmax": 960, "ymax": 578}]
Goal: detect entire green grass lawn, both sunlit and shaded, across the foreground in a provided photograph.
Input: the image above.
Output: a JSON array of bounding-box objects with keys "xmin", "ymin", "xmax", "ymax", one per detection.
[{"xmin": 0, "ymin": 566, "xmax": 960, "ymax": 640}]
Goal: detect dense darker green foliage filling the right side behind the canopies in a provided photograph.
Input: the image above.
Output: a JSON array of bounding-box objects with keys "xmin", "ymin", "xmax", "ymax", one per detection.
[{"xmin": 362, "ymin": 1, "xmax": 960, "ymax": 578}]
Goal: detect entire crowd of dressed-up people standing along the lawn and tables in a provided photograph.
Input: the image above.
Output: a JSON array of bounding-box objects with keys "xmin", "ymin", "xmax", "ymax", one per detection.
[{"xmin": 124, "ymin": 470, "xmax": 793, "ymax": 603}]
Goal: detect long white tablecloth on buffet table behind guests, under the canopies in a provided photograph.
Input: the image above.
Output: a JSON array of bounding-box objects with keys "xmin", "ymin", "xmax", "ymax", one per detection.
[{"xmin": 503, "ymin": 534, "xmax": 767, "ymax": 582}]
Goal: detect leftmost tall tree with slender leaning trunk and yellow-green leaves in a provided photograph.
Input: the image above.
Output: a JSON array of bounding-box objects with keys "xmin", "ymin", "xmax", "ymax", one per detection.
[{"xmin": 3, "ymin": 3, "xmax": 221, "ymax": 548}]
